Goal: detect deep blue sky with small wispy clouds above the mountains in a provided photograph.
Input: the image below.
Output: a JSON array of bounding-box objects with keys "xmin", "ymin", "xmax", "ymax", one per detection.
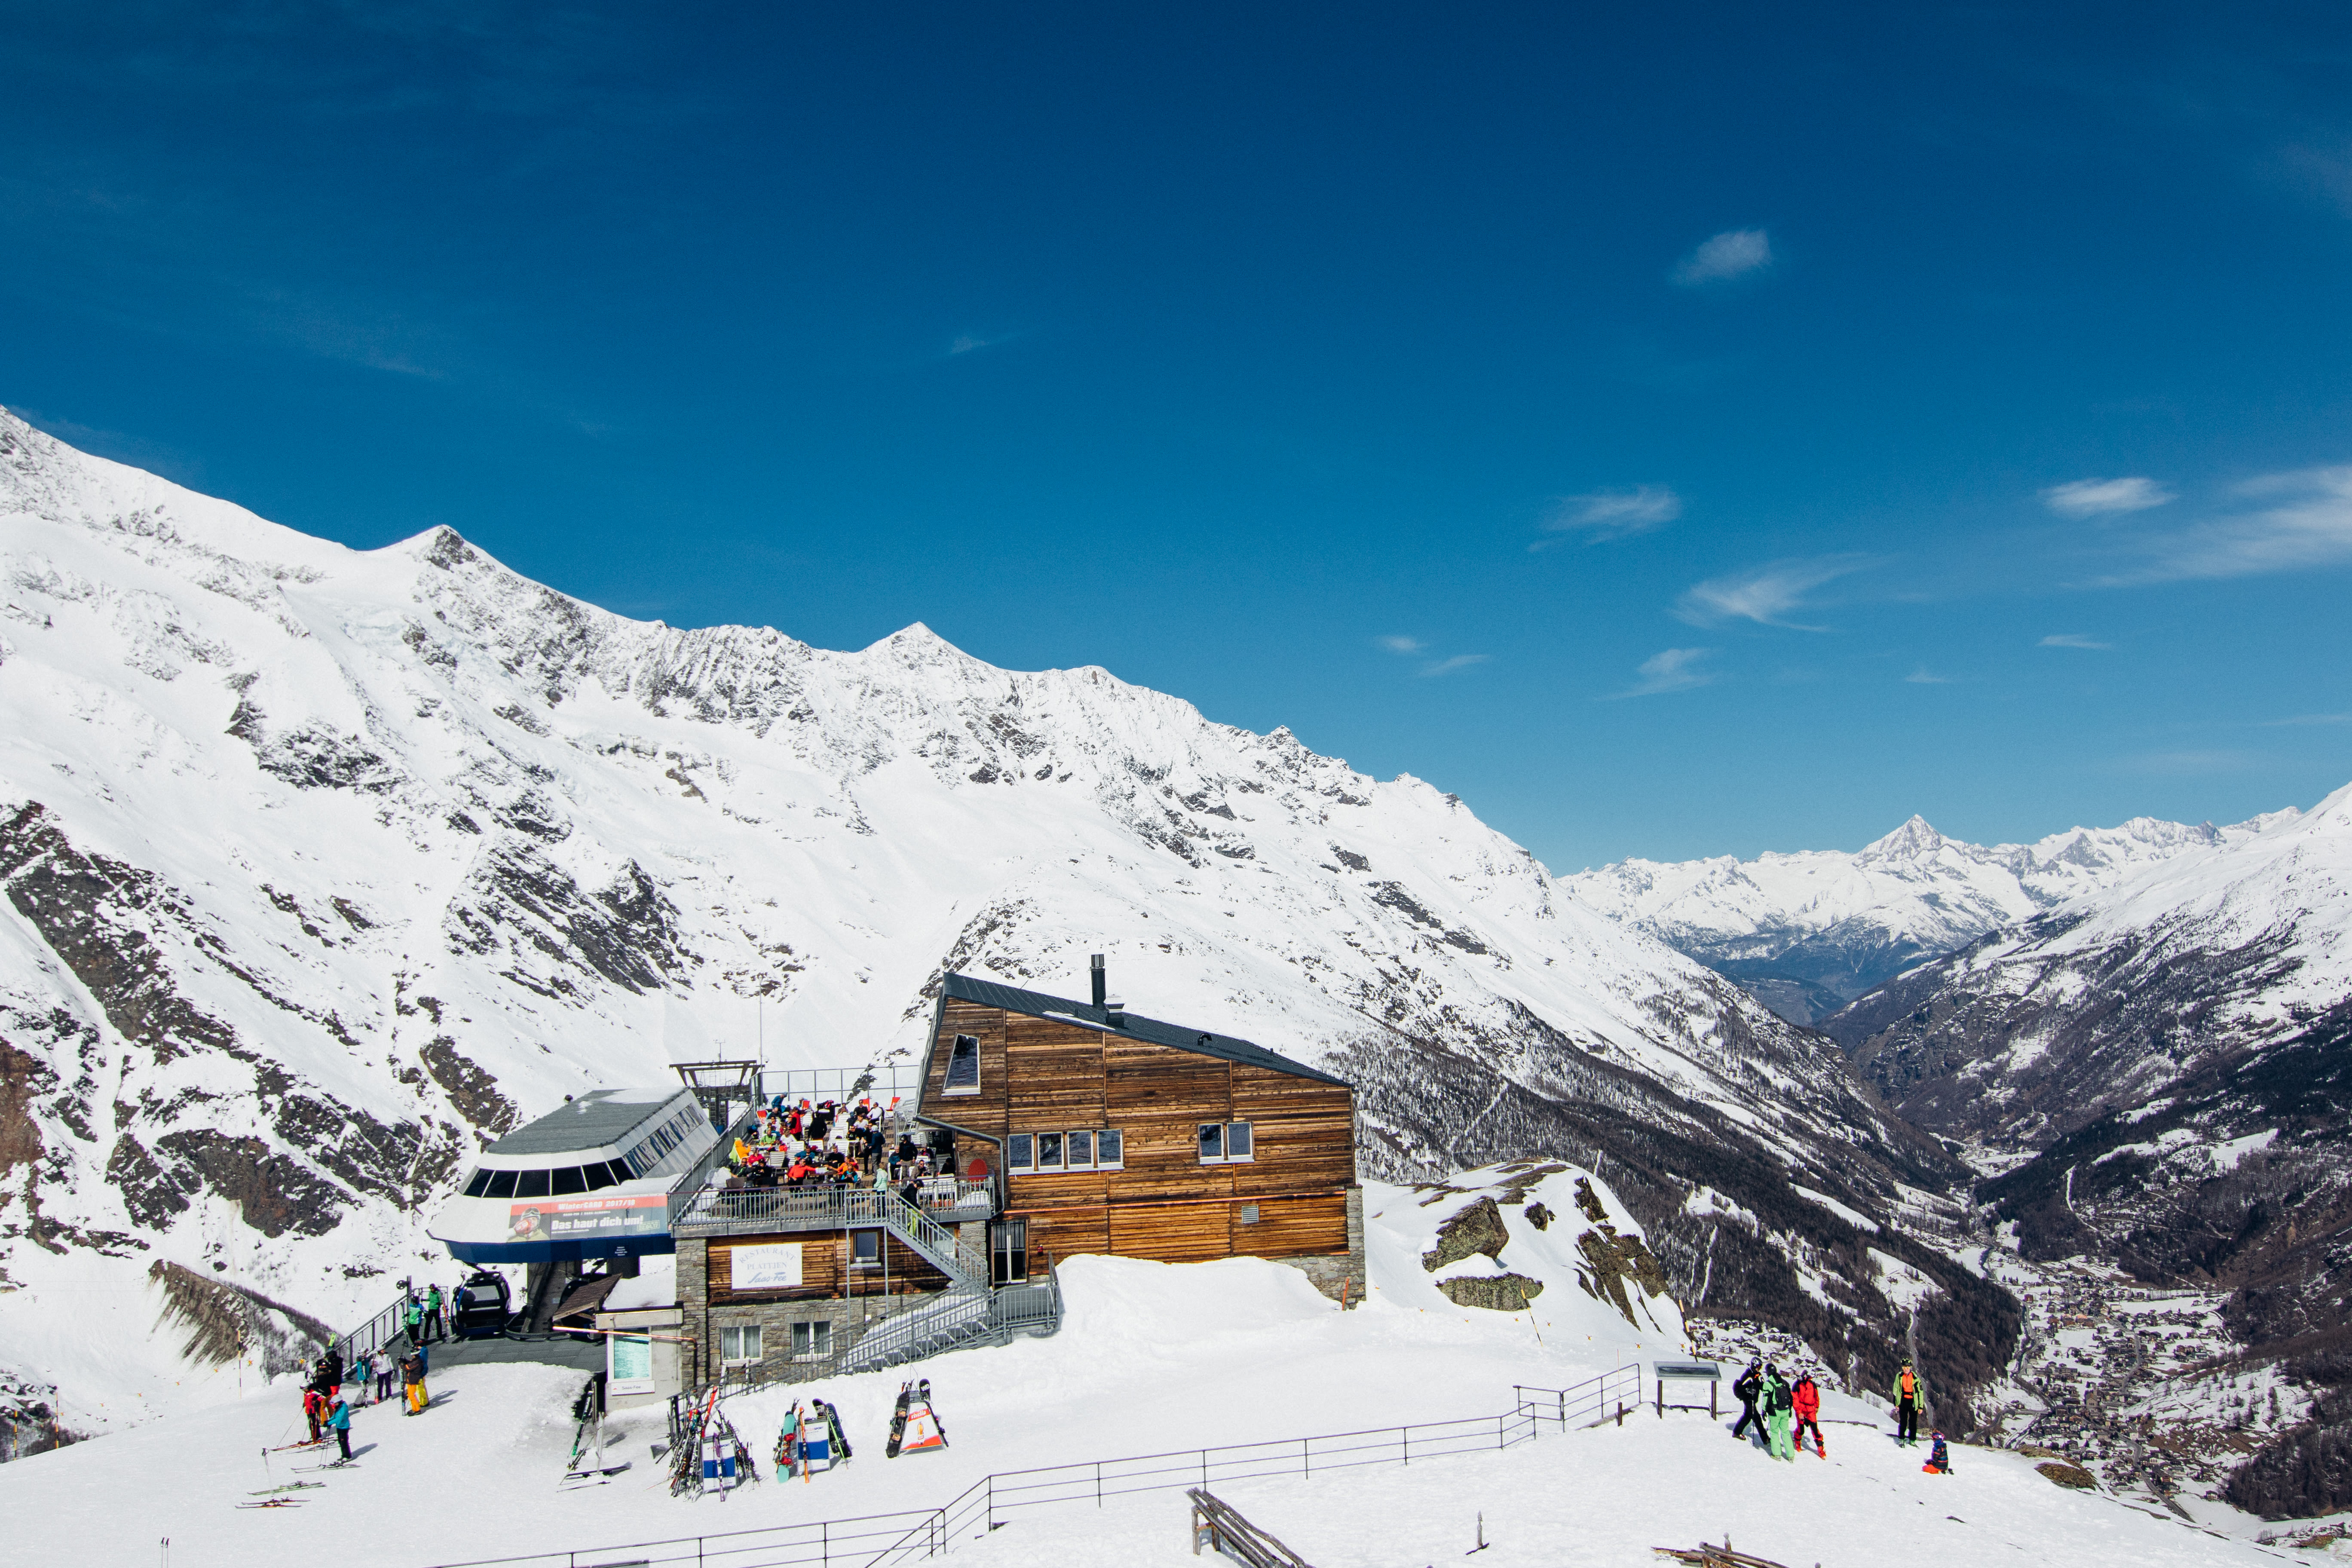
[{"xmin": 0, "ymin": 5, "xmax": 2352, "ymax": 870}]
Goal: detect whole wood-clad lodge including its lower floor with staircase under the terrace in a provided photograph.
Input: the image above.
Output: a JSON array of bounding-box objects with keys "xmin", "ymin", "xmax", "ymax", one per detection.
[{"xmin": 671, "ymin": 957, "xmax": 1364, "ymax": 1384}]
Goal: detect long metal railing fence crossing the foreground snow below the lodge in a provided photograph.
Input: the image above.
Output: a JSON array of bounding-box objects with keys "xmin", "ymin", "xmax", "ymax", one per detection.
[{"xmin": 440, "ymin": 1366, "xmax": 1642, "ymax": 1568}]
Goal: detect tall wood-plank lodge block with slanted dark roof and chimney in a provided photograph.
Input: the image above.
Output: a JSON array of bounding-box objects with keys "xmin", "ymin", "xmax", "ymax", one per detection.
[{"xmin": 917, "ymin": 957, "xmax": 1364, "ymax": 1305}]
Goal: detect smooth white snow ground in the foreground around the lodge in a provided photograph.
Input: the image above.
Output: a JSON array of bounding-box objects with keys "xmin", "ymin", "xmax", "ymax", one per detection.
[{"xmin": 0, "ymin": 1222, "xmax": 2277, "ymax": 1568}]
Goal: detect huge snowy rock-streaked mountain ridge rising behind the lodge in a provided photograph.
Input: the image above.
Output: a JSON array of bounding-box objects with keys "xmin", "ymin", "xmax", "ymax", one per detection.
[{"xmin": 0, "ymin": 416, "xmax": 2013, "ymax": 1457}]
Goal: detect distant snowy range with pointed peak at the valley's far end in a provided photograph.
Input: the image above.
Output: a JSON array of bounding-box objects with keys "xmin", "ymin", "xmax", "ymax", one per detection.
[{"xmin": 1562, "ymin": 811, "xmax": 2296, "ymax": 1023}]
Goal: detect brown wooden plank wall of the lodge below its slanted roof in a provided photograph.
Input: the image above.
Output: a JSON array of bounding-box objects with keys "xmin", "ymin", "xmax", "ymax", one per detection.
[{"xmin": 924, "ymin": 999, "xmax": 1355, "ymax": 1262}]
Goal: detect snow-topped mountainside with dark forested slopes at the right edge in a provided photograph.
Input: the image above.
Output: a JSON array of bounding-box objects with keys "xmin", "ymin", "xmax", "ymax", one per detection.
[{"xmin": 1823, "ymin": 785, "xmax": 2352, "ymax": 1512}]
